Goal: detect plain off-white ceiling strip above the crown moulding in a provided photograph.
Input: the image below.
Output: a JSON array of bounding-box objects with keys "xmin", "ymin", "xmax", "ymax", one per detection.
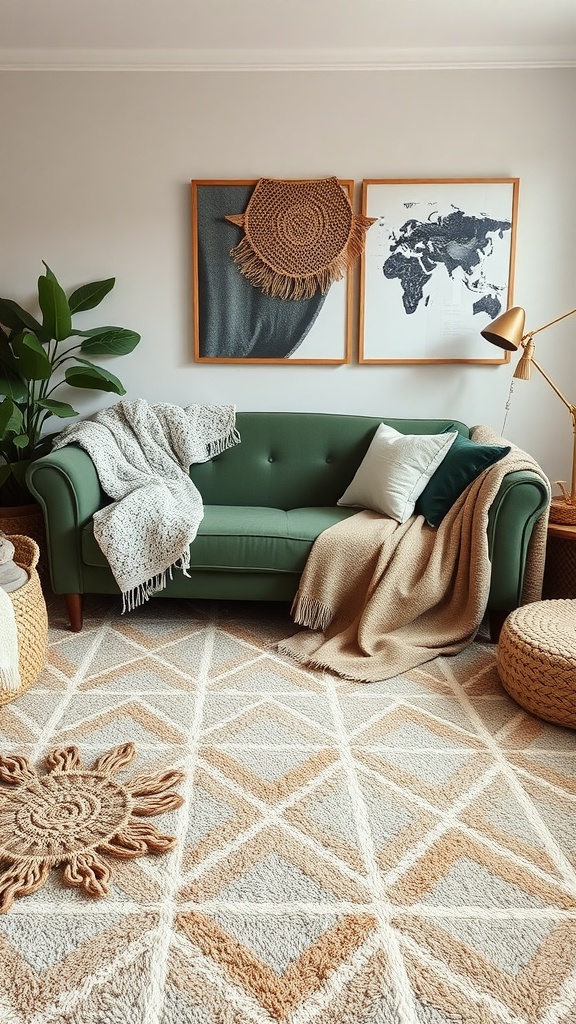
[{"xmin": 0, "ymin": 0, "xmax": 576, "ymax": 69}]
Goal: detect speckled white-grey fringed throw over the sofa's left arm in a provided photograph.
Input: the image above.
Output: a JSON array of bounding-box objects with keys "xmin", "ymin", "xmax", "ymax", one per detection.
[{"xmin": 53, "ymin": 398, "xmax": 240, "ymax": 610}]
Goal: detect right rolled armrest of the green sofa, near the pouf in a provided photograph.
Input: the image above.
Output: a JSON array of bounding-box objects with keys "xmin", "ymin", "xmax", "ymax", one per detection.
[{"xmin": 488, "ymin": 470, "xmax": 549, "ymax": 611}]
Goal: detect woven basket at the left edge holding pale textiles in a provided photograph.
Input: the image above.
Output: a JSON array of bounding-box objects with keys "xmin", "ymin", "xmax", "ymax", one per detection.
[{"xmin": 0, "ymin": 534, "xmax": 48, "ymax": 707}]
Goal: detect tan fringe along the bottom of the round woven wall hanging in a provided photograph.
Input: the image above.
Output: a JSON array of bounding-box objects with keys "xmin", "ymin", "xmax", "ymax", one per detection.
[{"xmin": 229, "ymin": 214, "xmax": 375, "ymax": 301}]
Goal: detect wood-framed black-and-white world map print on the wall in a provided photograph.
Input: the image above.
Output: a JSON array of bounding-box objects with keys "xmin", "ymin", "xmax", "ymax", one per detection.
[{"xmin": 359, "ymin": 178, "xmax": 520, "ymax": 365}]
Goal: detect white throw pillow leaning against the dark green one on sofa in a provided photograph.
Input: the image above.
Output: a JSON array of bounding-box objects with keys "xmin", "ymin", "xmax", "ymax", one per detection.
[{"xmin": 337, "ymin": 423, "xmax": 457, "ymax": 522}]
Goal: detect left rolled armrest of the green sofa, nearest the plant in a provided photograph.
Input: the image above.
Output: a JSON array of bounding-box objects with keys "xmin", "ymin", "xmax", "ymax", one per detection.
[{"xmin": 26, "ymin": 445, "xmax": 107, "ymax": 594}]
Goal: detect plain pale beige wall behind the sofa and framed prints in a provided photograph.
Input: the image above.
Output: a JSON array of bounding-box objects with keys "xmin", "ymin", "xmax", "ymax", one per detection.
[{"xmin": 0, "ymin": 69, "xmax": 576, "ymax": 480}]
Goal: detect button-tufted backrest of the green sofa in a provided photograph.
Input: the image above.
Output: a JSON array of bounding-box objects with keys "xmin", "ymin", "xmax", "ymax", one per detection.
[{"xmin": 190, "ymin": 412, "xmax": 469, "ymax": 509}]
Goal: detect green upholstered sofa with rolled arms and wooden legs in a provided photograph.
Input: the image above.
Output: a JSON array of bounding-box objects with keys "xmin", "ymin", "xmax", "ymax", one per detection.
[{"xmin": 27, "ymin": 412, "xmax": 548, "ymax": 638}]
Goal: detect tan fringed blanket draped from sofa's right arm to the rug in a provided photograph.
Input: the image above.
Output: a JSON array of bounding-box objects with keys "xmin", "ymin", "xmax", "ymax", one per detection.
[{"xmin": 278, "ymin": 427, "xmax": 549, "ymax": 683}]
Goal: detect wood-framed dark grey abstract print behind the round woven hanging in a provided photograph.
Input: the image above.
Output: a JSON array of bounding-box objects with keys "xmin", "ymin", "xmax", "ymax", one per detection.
[{"xmin": 191, "ymin": 178, "xmax": 354, "ymax": 366}]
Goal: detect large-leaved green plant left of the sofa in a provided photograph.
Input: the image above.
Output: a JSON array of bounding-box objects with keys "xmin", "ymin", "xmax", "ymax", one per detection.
[{"xmin": 0, "ymin": 261, "xmax": 140, "ymax": 507}]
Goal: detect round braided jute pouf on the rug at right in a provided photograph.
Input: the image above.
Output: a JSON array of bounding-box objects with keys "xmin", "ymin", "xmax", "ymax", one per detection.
[{"xmin": 497, "ymin": 600, "xmax": 576, "ymax": 728}]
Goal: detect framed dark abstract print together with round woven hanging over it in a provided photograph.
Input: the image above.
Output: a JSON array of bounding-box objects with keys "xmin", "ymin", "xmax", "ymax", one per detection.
[{"xmin": 192, "ymin": 178, "xmax": 356, "ymax": 365}]
